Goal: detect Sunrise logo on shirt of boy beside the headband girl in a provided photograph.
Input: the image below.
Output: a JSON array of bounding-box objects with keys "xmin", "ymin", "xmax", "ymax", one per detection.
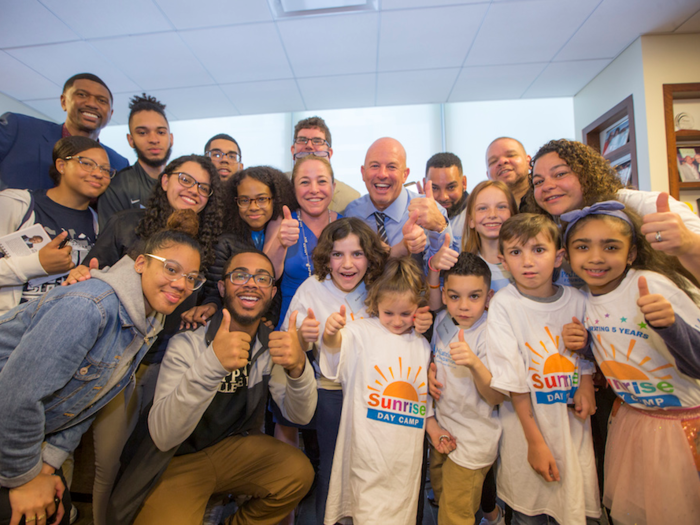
[{"xmin": 525, "ymin": 326, "xmax": 579, "ymax": 405}]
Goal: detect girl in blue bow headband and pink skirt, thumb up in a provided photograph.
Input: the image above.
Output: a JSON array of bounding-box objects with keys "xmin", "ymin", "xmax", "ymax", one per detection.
[{"xmin": 561, "ymin": 201, "xmax": 700, "ymax": 524}]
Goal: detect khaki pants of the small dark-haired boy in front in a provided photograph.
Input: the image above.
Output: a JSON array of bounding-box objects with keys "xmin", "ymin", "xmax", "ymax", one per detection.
[{"xmin": 430, "ymin": 445, "xmax": 491, "ymax": 525}]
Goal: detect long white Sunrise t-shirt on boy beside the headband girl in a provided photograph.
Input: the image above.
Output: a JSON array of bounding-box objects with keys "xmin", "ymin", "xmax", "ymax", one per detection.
[{"xmin": 487, "ymin": 284, "xmax": 600, "ymax": 525}]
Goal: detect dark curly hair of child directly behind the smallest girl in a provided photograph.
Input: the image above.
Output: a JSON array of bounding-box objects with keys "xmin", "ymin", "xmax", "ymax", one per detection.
[{"xmin": 313, "ymin": 217, "xmax": 389, "ymax": 286}]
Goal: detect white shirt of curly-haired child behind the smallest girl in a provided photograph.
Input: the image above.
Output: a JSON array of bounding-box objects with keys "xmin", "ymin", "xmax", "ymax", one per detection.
[{"xmin": 281, "ymin": 275, "xmax": 369, "ymax": 390}]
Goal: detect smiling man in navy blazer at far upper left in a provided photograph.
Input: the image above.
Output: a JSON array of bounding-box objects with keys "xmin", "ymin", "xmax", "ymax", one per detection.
[{"xmin": 0, "ymin": 73, "xmax": 129, "ymax": 190}]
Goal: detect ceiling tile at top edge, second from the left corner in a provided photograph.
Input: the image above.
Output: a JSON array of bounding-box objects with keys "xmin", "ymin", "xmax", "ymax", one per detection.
[{"xmin": 42, "ymin": 0, "xmax": 173, "ymax": 38}]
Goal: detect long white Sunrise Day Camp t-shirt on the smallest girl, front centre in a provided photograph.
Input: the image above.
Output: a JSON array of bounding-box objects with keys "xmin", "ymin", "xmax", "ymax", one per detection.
[{"xmin": 320, "ymin": 317, "xmax": 432, "ymax": 525}]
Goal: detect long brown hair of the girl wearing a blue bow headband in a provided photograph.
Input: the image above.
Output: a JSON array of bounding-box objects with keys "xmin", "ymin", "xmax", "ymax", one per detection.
[{"xmin": 562, "ymin": 202, "xmax": 700, "ymax": 305}]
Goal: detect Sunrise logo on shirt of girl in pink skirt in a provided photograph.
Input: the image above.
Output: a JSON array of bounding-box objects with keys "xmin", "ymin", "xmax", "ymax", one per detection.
[{"xmin": 596, "ymin": 334, "xmax": 682, "ymax": 408}]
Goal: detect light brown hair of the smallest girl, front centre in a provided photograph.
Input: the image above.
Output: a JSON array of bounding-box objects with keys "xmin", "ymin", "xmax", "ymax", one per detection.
[{"xmin": 365, "ymin": 256, "xmax": 428, "ymax": 317}]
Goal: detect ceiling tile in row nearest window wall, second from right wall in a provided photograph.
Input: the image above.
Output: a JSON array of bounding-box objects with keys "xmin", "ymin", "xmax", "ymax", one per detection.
[{"xmin": 449, "ymin": 63, "xmax": 547, "ymax": 102}]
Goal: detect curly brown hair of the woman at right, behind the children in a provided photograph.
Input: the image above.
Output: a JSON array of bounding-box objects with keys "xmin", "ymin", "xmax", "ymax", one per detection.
[{"xmin": 523, "ymin": 139, "xmax": 624, "ymax": 215}]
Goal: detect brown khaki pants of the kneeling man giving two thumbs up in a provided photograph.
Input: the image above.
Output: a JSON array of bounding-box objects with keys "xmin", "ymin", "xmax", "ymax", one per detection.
[{"xmin": 134, "ymin": 435, "xmax": 314, "ymax": 525}]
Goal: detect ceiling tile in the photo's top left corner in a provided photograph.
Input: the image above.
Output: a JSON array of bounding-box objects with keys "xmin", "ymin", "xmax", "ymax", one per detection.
[{"xmin": 0, "ymin": 0, "xmax": 80, "ymax": 49}]
